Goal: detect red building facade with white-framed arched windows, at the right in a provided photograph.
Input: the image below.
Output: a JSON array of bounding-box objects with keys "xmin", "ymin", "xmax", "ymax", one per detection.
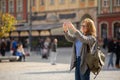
[{"xmin": 97, "ymin": 0, "xmax": 120, "ymax": 43}]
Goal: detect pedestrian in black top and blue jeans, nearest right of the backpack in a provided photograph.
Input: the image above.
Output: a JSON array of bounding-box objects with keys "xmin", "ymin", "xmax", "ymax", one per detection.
[{"xmin": 108, "ymin": 39, "xmax": 115, "ymax": 68}]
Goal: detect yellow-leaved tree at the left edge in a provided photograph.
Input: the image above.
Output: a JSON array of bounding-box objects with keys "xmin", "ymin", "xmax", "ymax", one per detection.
[{"xmin": 0, "ymin": 13, "xmax": 17, "ymax": 37}]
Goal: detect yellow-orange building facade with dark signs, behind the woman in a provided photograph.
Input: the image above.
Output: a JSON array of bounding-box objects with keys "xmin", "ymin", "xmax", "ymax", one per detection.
[{"xmin": 28, "ymin": 0, "xmax": 97, "ymax": 35}]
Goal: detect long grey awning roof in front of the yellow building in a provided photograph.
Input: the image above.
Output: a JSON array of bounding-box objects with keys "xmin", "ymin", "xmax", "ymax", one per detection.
[{"xmin": 16, "ymin": 23, "xmax": 62, "ymax": 31}]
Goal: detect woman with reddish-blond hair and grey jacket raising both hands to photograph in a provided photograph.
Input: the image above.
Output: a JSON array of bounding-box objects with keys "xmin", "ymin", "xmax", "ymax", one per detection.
[{"xmin": 63, "ymin": 18, "xmax": 96, "ymax": 80}]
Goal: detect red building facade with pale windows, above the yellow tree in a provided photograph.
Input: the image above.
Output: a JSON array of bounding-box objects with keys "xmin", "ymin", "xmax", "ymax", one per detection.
[{"xmin": 0, "ymin": 0, "xmax": 27, "ymax": 23}]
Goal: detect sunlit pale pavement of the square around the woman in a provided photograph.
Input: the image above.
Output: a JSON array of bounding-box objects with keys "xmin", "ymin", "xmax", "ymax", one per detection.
[{"xmin": 0, "ymin": 48, "xmax": 120, "ymax": 80}]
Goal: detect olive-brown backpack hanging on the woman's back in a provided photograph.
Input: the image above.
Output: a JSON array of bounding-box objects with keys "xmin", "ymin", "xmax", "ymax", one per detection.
[{"xmin": 86, "ymin": 41, "xmax": 105, "ymax": 79}]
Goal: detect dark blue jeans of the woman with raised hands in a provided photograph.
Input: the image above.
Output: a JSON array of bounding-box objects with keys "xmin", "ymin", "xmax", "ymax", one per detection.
[{"xmin": 75, "ymin": 57, "xmax": 90, "ymax": 80}]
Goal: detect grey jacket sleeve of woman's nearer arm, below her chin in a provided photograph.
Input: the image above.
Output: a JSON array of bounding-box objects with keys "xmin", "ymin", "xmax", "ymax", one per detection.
[{"xmin": 75, "ymin": 30, "xmax": 96, "ymax": 44}]
